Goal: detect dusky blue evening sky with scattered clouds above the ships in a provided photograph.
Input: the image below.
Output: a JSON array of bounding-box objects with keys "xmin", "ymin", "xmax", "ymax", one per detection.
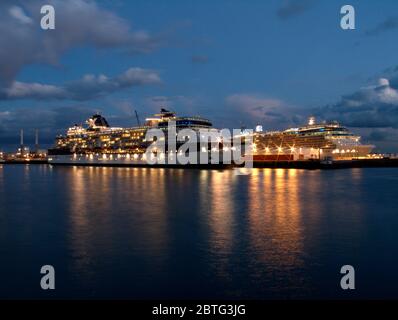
[{"xmin": 0, "ymin": 0, "xmax": 398, "ymax": 152}]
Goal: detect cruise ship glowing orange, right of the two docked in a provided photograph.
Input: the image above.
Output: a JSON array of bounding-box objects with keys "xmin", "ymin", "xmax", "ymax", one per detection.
[{"xmin": 253, "ymin": 117, "xmax": 374, "ymax": 162}]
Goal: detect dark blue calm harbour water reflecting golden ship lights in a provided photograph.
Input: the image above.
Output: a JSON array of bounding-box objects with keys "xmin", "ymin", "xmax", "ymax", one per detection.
[{"xmin": 0, "ymin": 165, "xmax": 398, "ymax": 299}]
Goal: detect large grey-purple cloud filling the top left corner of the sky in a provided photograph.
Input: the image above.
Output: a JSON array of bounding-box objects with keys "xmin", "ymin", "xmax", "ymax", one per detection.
[{"xmin": 0, "ymin": 0, "xmax": 165, "ymax": 86}]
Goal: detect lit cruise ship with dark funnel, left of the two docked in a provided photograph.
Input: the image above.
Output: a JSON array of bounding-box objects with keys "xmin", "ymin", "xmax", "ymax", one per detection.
[{"xmin": 48, "ymin": 108, "xmax": 225, "ymax": 166}]
